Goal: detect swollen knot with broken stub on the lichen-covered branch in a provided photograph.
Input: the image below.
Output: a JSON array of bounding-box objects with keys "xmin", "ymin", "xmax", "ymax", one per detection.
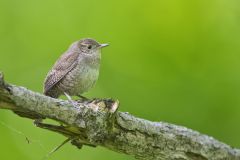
[{"xmin": 72, "ymin": 99, "xmax": 119, "ymax": 145}]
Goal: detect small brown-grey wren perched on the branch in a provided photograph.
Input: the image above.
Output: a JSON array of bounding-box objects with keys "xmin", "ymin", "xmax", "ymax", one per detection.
[{"xmin": 44, "ymin": 38, "xmax": 108, "ymax": 99}]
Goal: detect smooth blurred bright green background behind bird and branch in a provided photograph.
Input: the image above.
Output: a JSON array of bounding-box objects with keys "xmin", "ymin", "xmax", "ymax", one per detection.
[{"xmin": 0, "ymin": 0, "xmax": 240, "ymax": 160}]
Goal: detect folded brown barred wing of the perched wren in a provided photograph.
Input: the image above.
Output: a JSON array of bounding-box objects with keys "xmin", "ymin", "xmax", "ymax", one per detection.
[{"xmin": 44, "ymin": 52, "xmax": 79, "ymax": 94}]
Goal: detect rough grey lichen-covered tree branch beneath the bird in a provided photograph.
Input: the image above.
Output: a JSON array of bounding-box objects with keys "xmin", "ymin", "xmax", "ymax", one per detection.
[{"xmin": 0, "ymin": 73, "xmax": 240, "ymax": 160}]
